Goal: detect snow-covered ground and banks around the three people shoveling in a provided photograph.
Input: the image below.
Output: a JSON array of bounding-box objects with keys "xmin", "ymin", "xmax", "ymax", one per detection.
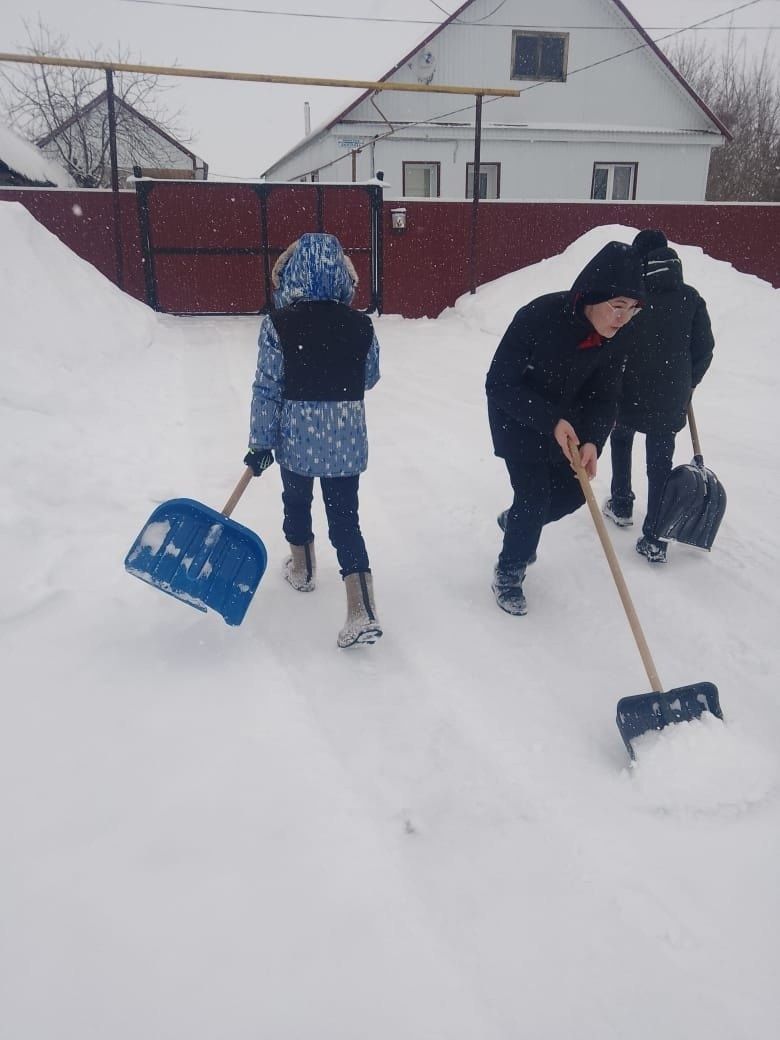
[{"xmin": 0, "ymin": 204, "xmax": 780, "ymax": 1040}]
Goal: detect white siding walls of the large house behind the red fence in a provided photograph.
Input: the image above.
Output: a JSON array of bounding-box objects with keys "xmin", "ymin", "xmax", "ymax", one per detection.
[{"xmin": 269, "ymin": 0, "xmax": 721, "ymax": 201}]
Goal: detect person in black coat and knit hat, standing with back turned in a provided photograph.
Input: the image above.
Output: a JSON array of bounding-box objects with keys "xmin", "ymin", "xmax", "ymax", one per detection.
[{"xmin": 603, "ymin": 230, "xmax": 713, "ymax": 564}]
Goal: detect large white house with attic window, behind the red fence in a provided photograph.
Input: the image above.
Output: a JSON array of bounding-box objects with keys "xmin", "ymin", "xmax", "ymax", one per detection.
[{"xmin": 262, "ymin": 0, "xmax": 728, "ymax": 202}]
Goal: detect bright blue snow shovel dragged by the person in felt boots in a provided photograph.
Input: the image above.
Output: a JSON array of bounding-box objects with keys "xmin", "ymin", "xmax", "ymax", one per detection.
[{"xmin": 125, "ymin": 466, "xmax": 268, "ymax": 625}]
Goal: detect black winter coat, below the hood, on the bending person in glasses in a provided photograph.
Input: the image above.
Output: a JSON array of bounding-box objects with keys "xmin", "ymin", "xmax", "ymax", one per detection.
[{"xmin": 485, "ymin": 292, "xmax": 625, "ymax": 459}]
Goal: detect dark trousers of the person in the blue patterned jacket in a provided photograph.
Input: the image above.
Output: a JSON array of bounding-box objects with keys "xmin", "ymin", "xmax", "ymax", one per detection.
[{"xmin": 282, "ymin": 469, "xmax": 370, "ymax": 578}]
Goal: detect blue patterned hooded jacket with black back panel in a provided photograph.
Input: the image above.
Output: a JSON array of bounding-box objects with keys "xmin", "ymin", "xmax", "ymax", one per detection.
[{"xmin": 250, "ymin": 234, "xmax": 380, "ymax": 476}]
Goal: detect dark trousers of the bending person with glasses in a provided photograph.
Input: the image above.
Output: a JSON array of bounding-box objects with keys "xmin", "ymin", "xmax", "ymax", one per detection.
[{"xmin": 498, "ymin": 431, "xmax": 584, "ymax": 570}]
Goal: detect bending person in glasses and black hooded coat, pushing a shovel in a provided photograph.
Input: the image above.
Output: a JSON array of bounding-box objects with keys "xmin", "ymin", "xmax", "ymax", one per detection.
[{"xmin": 486, "ymin": 242, "xmax": 645, "ymax": 615}]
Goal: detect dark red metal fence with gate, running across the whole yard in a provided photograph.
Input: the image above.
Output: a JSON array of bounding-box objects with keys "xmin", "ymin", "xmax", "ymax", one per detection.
[{"xmin": 0, "ymin": 181, "xmax": 780, "ymax": 317}]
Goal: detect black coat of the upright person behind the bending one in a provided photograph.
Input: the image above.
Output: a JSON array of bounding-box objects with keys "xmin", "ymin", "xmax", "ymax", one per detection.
[{"xmin": 618, "ymin": 249, "xmax": 714, "ymax": 434}]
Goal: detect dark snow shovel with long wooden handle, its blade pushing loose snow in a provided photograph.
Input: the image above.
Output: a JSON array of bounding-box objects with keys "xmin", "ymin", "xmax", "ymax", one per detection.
[{"xmin": 569, "ymin": 441, "xmax": 723, "ymax": 759}]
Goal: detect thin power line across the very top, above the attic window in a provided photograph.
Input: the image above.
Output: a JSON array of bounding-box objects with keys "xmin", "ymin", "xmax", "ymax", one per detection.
[{"xmin": 120, "ymin": 0, "xmax": 780, "ymax": 32}]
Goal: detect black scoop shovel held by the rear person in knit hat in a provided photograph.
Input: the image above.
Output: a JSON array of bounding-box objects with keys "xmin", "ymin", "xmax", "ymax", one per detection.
[{"xmin": 654, "ymin": 405, "xmax": 726, "ymax": 551}]
